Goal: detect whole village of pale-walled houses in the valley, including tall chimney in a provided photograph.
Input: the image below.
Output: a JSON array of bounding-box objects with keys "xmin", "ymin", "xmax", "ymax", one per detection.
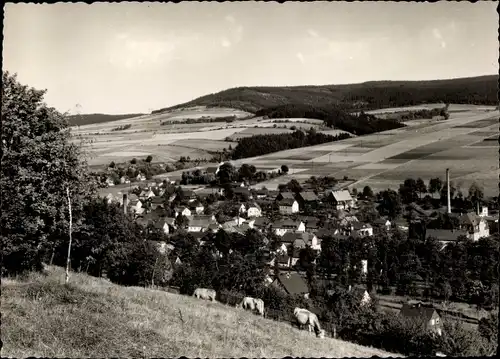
[{"xmin": 99, "ymin": 163, "xmax": 498, "ymax": 331}]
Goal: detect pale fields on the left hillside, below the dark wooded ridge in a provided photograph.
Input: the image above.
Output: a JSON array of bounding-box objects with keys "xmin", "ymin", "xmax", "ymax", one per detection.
[{"xmin": 71, "ymin": 106, "xmax": 344, "ymax": 165}]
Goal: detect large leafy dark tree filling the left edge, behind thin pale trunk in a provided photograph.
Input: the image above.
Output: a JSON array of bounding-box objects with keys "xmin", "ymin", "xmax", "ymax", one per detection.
[{"xmin": 0, "ymin": 72, "xmax": 97, "ymax": 274}]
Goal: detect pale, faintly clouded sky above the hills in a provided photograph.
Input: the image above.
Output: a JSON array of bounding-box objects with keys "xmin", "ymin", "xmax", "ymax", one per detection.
[{"xmin": 2, "ymin": 1, "xmax": 499, "ymax": 114}]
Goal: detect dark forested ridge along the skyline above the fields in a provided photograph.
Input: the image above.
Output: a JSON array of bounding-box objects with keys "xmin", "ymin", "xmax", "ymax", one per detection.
[{"xmin": 153, "ymin": 75, "xmax": 498, "ymax": 113}]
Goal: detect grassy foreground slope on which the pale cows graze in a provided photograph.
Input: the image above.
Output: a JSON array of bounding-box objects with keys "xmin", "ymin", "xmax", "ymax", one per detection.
[{"xmin": 1, "ymin": 267, "xmax": 394, "ymax": 358}]
